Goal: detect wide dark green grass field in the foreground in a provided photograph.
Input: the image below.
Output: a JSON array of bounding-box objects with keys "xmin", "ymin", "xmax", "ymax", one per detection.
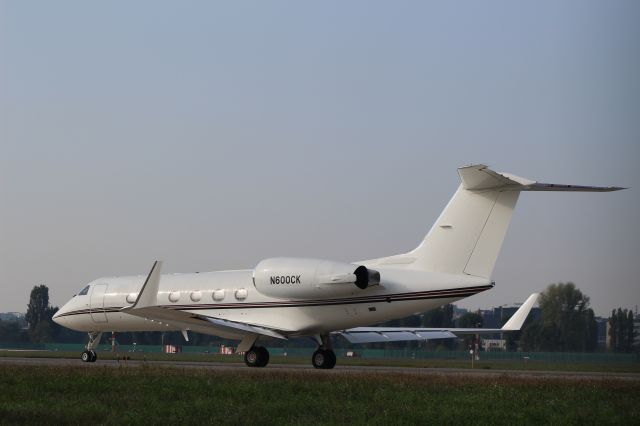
[{"xmin": 0, "ymin": 365, "xmax": 640, "ymax": 425}]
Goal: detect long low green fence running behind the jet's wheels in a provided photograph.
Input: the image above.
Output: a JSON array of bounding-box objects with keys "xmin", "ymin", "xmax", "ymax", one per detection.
[{"xmin": 0, "ymin": 343, "xmax": 640, "ymax": 364}]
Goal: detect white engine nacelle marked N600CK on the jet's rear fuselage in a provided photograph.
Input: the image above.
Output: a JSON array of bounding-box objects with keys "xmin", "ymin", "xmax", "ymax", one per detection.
[{"xmin": 253, "ymin": 257, "xmax": 380, "ymax": 299}]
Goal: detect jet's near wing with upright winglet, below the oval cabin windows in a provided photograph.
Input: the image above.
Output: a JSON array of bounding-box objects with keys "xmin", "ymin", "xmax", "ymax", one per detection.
[{"xmin": 122, "ymin": 261, "xmax": 287, "ymax": 339}]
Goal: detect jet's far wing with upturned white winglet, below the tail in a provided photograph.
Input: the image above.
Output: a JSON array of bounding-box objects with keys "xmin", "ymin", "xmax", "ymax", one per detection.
[{"xmin": 334, "ymin": 293, "xmax": 538, "ymax": 343}]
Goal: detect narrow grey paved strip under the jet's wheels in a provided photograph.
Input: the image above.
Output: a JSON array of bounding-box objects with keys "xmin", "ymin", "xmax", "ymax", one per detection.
[{"xmin": 0, "ymin": 357, "xmax": 640, "ymax": 382}]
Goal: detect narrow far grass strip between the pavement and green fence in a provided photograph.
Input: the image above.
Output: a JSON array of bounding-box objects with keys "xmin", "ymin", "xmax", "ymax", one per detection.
[{"xmin": 0, "ymin": 351, "xmax": 640, "ymax": 373}]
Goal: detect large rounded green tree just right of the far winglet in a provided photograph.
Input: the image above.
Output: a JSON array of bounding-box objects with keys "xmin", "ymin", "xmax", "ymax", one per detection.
[{"xmin": 520, "ymin": 282, "xmax": 597, "ymax": 351}]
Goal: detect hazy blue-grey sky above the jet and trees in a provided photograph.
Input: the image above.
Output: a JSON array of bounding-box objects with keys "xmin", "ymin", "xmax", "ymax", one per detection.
[{"xmin": 0, "ymin": 0, "xmax": 640, "ymax": 315}]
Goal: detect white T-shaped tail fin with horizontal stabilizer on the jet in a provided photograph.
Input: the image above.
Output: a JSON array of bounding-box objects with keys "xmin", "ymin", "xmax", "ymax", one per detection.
[{"xmin": 406, "ymin": 164, "xmax": 624, "ymax": 278}]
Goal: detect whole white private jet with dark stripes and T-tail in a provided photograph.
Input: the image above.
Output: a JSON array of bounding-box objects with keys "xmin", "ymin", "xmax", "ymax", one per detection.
[{"xmin": 53, "ymin": 164, "xmax": 623, "ymax": 369}]
